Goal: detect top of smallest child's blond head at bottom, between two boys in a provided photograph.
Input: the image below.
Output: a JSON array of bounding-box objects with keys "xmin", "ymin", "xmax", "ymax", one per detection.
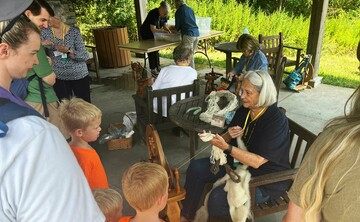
[{"xmin": 92, "ymin": 188, "xmax": 123, "ymax": 222}]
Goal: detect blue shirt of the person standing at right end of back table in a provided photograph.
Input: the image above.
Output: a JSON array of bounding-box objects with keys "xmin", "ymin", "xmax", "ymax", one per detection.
[{"xmin": 175, "ymin": 4, "xmax": 200, "ymax": 37}]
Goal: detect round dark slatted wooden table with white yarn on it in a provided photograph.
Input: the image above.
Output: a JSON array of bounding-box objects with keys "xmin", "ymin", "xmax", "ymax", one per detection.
[{"xmin": 168, "ymin": 96, "xmax": 226, "ymax": 158}]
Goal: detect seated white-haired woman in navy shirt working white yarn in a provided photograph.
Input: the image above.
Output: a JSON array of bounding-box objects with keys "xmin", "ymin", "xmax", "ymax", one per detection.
[{"xmin": 181, "ymin": 70, "xmax": 290, "ymax": 221}]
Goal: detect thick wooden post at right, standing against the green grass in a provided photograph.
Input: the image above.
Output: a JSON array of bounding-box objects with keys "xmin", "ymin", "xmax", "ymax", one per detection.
[{"xmin": 306, "ymin": 0, "xmax": 329, "ymax": 87}]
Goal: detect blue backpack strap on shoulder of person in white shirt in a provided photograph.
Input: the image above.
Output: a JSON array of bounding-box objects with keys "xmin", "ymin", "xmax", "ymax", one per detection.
[{"xmin": 0, "ymin": 97, "xmax": 44, "ymax": 138}]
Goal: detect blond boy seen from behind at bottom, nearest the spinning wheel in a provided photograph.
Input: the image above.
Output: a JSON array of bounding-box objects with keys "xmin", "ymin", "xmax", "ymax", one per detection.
[{"xmin": 119, "ymin": 162, "xmax": 169, "ymax": 222}]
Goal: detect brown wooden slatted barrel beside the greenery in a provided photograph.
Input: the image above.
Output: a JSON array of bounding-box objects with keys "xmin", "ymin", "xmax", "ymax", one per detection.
[{"xmin": 93, "ymin": 26, "xmax": 131, "ymax": 68}]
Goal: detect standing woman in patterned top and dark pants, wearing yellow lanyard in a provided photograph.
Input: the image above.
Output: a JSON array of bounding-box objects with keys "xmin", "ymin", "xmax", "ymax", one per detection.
[{"xmin": 41, "ymin": 8, "xmax": 91, "ymax": 103}]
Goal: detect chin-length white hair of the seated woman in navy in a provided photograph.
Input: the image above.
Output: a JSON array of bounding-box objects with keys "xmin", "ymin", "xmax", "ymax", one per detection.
[{"xmin": 244, "ymin": 70, "xmax": 277, "ymax": 107}]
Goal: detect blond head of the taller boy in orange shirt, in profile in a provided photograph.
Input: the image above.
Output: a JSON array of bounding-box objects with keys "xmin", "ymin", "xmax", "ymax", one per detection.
[{"xmin": 59, "ymin": 98, "xmax": 102, "ymax": 142}]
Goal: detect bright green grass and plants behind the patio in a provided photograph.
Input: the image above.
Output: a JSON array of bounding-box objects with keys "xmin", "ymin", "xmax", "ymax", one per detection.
[{"xmin": 72, "ymin": 0, "xmax": 360, "ymax": 87}]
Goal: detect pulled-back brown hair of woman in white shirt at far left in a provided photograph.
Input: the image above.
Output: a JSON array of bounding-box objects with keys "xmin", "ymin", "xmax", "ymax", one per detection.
[{"xmin": 0, "ymin": 16, "xmax": 40, "ymax": 49}]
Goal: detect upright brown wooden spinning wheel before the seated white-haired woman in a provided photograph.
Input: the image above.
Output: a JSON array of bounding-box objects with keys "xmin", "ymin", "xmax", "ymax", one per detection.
[{"xmin": 146, "ymin": 124, "xmax": 186, "ymax": 222}]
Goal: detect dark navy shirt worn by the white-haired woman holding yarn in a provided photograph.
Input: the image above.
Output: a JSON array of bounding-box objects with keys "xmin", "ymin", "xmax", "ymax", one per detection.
[{"xmin": 228, "ymin": 103, "xmax": 290, "ymax": 199}]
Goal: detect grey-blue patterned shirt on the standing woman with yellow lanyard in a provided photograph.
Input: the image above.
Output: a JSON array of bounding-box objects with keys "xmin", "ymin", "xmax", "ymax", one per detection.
[{"xmin": 41, "ymin": 26, "xmax": 89, "ymax": 80}]
